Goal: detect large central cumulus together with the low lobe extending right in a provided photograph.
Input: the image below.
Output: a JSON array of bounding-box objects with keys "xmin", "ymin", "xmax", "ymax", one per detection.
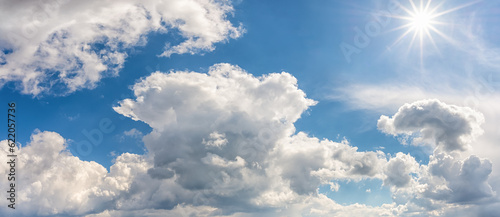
[{"xmin": 114, "ymin": 64, "xmax": 385, "ymax": 211}]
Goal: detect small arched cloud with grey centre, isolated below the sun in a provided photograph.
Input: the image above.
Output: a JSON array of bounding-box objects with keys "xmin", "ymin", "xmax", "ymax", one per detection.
[{"xmin": 377, "ymin": 100, "xmax": 484, "ymax": 151}]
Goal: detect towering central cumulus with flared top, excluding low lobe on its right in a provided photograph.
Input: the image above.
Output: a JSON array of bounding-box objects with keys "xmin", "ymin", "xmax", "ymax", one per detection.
[{"xmin": 114, "ymin": 64, "xmax": 315, "ymax": 203}]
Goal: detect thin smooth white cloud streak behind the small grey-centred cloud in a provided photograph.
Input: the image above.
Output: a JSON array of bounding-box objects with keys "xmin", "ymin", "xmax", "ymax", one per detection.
[{"xmin": 332, "ymin": 83, "xmax": 500, "ymax": 176}]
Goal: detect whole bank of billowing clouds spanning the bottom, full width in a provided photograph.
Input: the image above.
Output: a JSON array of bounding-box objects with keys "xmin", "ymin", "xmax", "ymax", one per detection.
[{"xmin": 0, "ymin": 64, "xmax": 498, "ymax": 216}]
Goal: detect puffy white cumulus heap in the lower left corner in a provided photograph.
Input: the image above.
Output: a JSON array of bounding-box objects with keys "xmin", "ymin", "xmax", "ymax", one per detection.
[{"xmin": 0, "ymin": 131, "xmax": 148, "ymax": 216}]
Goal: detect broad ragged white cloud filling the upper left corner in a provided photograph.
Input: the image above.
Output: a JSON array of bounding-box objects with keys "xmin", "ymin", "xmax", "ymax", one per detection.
[{"xmin": 0, "ymin": 0, "xmax": 244, "ymax": 95}]
